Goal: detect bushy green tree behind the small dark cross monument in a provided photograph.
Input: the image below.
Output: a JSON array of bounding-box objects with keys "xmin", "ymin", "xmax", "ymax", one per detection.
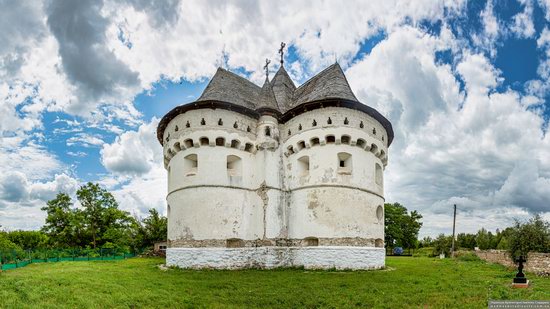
[{"xmin": 508, "ymin": 214, "xmax": 550, "ymax": 260}]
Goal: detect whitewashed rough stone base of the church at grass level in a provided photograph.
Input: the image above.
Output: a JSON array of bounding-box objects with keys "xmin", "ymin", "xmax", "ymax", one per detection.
[{"xmin": 166, "ymin": 246, "xmax": 386, "ymax": 270}]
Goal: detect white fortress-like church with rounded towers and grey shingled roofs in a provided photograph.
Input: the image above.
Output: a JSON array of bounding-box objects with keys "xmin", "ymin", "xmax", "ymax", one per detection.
[{"xmin": 157, "ymin": 49, "xmax": 393, "ymax": 269}]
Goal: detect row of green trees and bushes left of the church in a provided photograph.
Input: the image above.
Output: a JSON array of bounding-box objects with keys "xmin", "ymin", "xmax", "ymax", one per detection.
[{"xmin": 0, "ymin": 183, "xmax": 167, "ymax": 252}]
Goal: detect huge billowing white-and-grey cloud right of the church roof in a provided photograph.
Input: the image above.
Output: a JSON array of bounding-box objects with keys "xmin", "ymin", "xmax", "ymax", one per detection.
[{"xmin": 347, "ymin": 28, "xmax": 550, "ymax": 234}]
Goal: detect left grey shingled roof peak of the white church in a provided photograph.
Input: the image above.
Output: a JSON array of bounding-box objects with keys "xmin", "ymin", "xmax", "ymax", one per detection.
[{"xmin": 197, "ymin": 68, "xmax": 261, "ymax": 109}]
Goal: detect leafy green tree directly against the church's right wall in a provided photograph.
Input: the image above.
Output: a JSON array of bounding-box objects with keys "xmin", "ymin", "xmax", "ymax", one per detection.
[{"xmin": 384, "ymin": 203, "xmax": 422, "ymax": 248}]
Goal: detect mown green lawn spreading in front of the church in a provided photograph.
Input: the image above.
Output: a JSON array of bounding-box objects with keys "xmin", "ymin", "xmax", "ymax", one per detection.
[{"xmin": 0, "ymin": 257, "xmax": 550, "ymax": 308}]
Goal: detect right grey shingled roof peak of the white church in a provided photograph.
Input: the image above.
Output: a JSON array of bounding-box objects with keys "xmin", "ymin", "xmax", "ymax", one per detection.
[{"xmin": 292, "ymin": 63, "xmax": 359, "ymax": 107}]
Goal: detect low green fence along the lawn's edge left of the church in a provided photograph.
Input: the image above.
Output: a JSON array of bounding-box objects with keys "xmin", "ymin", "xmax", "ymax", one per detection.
[{"xmin": 0, "ymin": 248, "xmax": 137, "ymax": 270}]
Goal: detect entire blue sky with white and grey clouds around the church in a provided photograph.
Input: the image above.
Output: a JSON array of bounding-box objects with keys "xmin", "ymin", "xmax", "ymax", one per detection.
[{"xmin": 0, "ymin": 0, "xmax": 550, "ymax": 235}]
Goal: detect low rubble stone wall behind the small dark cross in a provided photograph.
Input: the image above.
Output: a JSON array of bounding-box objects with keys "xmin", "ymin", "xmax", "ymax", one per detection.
[{"xmin": 475, "ymin": 250, "xmax": 550, "ymax": 274}]
